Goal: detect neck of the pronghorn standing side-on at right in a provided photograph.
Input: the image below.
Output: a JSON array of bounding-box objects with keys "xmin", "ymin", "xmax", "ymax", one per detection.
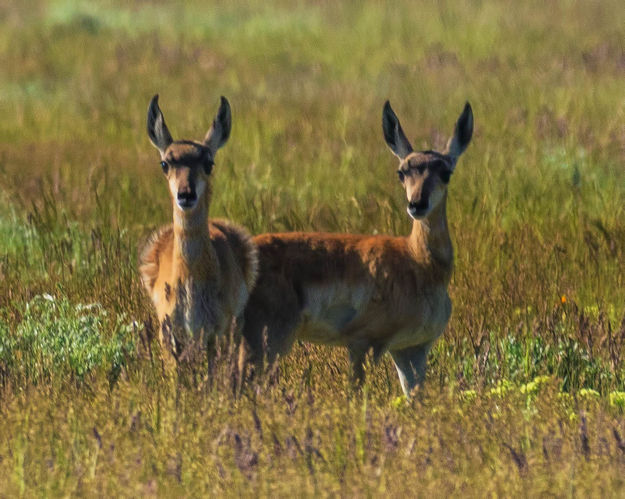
[{"xmin": 409, "ymin": 193, "xmax": 454, "ymax": 277}]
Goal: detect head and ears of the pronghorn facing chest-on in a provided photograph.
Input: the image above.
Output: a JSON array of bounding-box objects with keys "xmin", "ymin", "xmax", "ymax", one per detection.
[{"xmin": 148, "ymin": 95, "xmax": 232, "ymax": 212}]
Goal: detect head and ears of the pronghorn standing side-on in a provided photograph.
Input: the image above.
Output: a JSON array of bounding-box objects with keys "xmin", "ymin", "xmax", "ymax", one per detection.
[{"xmin": 382, "ymin": 101, "xmax": 473, "ymax": 220}]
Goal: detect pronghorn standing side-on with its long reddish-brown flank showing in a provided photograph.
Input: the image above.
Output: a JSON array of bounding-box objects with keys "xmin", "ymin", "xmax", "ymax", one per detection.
[{"xmin": 243, "ymin": 102, "xmax": 473, "ymax": 395}]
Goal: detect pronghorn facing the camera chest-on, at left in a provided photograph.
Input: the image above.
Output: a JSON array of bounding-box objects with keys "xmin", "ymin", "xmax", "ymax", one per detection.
[{"xmin": 140, "ymin": 95, "xmax": 258, "ymax": 353}]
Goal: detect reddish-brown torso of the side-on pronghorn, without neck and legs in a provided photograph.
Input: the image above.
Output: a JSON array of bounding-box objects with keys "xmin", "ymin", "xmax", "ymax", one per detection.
[{"xmin": 246, "ymin": 232, "xmax": 452, "ymax": 355}]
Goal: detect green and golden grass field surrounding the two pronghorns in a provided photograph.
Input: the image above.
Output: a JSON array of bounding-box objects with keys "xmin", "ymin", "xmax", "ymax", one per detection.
[{"xmin": 0, "ymin": 0, "xmax": 625, "ymax": 497}]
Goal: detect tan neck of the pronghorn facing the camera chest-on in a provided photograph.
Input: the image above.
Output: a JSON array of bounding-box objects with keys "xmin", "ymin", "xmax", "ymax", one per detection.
[{"xmin": 173, "ymin": 202, "xmax": 216, "ymax": 281}]
